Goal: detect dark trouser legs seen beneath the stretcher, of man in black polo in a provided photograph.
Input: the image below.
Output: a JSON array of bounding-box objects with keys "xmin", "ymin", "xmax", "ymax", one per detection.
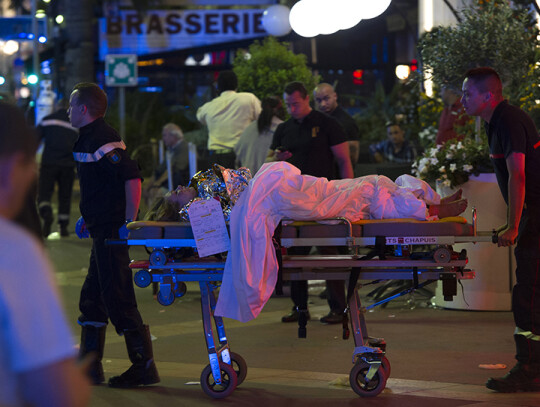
[{"xmin": 288, "ymin": 246, "xmax": 347, "ymax": 313}]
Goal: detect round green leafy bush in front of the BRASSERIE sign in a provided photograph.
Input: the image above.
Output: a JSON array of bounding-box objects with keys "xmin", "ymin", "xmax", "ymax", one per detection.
[{"xmin": 233, "ymin": 37, "xmax": 320, "ymax": 100}]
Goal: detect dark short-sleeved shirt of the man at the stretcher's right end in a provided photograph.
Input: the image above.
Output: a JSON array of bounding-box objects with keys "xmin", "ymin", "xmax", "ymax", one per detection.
[{"xmin": 486, "ymin": 101, "xmax": 540, "ymax": 208}]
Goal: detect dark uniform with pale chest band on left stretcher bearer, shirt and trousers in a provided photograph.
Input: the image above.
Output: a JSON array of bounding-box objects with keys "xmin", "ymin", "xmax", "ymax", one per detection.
[{"xmin": 73, "ymin": 118, "xmax": 142, "ymax": 333}]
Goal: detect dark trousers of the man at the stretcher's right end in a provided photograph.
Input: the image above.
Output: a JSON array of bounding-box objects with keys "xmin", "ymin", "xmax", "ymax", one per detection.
[{"xmin": 512, "ymin": 208, "xmax": 540, "ymax": 336}]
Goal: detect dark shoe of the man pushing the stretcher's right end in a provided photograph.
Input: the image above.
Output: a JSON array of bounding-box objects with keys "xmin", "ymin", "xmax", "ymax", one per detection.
[{"xmin": 486, "ymin": 362, "xmax": 540, "ymax": 393}]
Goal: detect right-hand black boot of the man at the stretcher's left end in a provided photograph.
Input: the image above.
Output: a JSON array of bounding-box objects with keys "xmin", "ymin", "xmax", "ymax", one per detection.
[{"xmin": 109, "ymin": 325, "xmax": 160, "ymax": 388}]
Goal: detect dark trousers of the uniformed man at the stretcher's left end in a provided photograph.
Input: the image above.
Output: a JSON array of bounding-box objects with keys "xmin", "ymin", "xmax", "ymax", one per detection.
[{"xmin": 79, "ymin": 224, "xmax": 143, "ymax": 333}]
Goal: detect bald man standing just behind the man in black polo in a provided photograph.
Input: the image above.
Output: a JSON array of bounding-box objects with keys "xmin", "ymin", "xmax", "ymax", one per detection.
[{"xmin": 313, "ymin": 83, "xmax": 360, "ymax": 168}]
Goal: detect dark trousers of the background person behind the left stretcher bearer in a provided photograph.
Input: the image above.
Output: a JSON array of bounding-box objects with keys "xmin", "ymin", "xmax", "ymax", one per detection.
[{"xmin": 38, "ymin": 164, "xmax": 75, "ymax": 225}]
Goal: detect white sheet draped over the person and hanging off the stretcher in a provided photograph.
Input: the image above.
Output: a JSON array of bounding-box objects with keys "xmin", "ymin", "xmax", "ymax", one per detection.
[{"xmin": 215, "ymin": 161, "xmax": 440, "ymax": 322}]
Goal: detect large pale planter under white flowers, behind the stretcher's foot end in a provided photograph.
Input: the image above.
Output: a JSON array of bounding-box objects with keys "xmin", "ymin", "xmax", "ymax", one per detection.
[{"xmin": 434, "ymin": 173, "xmax": 515, "ymax": 311}]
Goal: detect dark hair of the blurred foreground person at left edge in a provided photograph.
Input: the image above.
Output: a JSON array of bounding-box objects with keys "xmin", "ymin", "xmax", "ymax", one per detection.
[{"xmin": 0, "ymin": 102, "xmax": 38, "ymax": 158}]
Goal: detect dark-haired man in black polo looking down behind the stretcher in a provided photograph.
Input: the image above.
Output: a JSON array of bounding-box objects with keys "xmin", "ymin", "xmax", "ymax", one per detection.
[{"xmin": 269, "ymin": 82, "xmax": 354, "ymax": 322}]
